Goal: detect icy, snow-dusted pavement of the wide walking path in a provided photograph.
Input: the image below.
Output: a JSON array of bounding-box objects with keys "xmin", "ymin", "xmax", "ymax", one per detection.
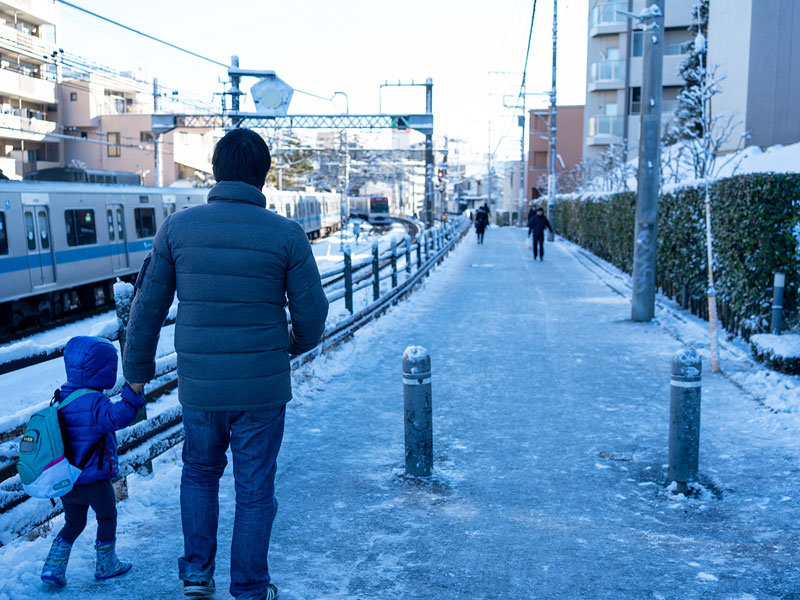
[{"xmin": 0, "ymin": 228, "xmax": 800, "ymax": 600}]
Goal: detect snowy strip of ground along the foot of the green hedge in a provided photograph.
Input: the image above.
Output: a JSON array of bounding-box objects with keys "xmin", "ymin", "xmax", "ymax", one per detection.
[{"xmin": 559, "ymin": 233, "xmax": 800, "ymax": 418}]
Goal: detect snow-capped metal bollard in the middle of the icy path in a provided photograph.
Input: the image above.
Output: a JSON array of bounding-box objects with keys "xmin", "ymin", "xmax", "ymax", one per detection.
[{"xmin": 403, "ymin": 346, "xmax": 433, "ymax": 477}]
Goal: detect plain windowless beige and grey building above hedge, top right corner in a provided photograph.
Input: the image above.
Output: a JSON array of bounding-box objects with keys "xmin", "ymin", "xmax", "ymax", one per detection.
[{"xmin": 708, "ymin": 0, "xmax": 800, "ymax": 150}]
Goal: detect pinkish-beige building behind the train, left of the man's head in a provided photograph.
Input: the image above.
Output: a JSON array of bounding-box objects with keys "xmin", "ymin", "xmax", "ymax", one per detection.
[{"xmin": 60, "ymin": 70, "xmax": 216, "ymax": 185}]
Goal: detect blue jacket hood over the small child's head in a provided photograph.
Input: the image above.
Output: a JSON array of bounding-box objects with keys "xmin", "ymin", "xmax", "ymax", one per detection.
[{"xmin": 64, "ymin": 336, "xmax": 117, "ymax": 390}]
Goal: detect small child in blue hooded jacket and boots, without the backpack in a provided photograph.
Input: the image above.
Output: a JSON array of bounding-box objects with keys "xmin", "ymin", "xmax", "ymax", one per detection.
[{"xmin": 42, "ymin": 336, "xmax": 145, "ymax": 587}]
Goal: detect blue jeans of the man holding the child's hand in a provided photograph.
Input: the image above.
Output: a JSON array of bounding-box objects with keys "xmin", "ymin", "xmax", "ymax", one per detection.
[{"xmin": 178, "ymin": 406, "xmax": 286, "ymax": 598}]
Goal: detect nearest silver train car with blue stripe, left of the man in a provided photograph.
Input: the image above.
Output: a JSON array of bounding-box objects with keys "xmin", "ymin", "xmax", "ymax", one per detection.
[{"xmin": 0, "ymin": 182, "xmax": 208, "ymax": 337}]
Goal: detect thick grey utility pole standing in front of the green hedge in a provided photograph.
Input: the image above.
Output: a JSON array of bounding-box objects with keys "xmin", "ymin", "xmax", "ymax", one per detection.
[{"xmin": 631, "ymin": 0, "xmax": 664, "ymax": 321}]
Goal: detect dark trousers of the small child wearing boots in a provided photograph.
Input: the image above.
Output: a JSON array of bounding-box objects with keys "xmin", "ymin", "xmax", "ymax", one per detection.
[{"xmin": 58, "ymin": 479, "xmax": 117, "ymax": 544}]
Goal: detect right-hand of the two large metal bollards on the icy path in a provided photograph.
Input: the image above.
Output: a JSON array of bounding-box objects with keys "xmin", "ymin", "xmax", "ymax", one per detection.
[{"xmin": 667, "ymin": 349, "xmax": 703, "ymax": 494}]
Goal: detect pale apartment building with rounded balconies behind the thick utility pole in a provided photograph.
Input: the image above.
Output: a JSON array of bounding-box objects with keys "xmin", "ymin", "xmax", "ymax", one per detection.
[{"xmin": 583, "ymin": 0, "xmax": 692, "ymax": 158}]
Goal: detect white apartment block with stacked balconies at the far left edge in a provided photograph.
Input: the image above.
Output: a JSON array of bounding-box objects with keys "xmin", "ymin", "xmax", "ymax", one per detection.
[{"xmin": 0, "ymin": 0, "xmax": 62, "ymax": 179}]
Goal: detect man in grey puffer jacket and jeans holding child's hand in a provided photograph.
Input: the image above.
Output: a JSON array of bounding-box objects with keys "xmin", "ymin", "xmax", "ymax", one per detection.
[{"xmin": 123, "ymin": 129, "xmax": 328, "ymax": 600}]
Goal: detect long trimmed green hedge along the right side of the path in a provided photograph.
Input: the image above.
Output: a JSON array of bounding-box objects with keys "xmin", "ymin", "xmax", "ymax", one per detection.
[{"xmin": 555, "ymin": 173, "xmax": 800, "ymax": 337}]
